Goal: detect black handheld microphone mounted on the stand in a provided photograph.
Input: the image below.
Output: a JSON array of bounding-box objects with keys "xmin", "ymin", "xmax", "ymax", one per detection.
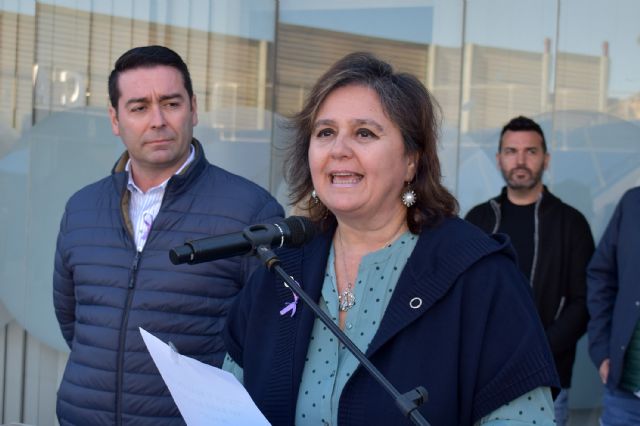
[{"xmin": 169, "ymin": 216, "xmax": 316, "ymax": 265}]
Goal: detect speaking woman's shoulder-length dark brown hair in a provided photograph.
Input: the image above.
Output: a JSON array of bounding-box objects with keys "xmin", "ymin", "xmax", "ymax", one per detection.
[{"xmin": 284, "ymin": 52, "xmax": 458, "ymax": 234}]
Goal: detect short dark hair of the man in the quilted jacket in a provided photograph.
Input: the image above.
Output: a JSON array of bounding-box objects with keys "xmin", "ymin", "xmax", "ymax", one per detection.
[{"xmin": 109, "ymin": 45, "xmax": 193, "ymax": 111}]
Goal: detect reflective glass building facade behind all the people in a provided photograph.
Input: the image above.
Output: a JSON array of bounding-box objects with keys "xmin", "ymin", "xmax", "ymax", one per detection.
[{"xmin": 0, "ymin": 0, "xmax": 640, "ymax": 425}]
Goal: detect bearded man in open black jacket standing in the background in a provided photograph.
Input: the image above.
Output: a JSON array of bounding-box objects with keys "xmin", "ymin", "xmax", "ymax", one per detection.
[{"xmin": 466, "ymin": 116, "xmax": 594, "ymax": 425}]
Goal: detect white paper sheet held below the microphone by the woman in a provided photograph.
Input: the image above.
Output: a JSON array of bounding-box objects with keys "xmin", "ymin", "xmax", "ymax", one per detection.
[{"xmin": 140, "ymin": 327, "xmax": 269, "ymax": 426}]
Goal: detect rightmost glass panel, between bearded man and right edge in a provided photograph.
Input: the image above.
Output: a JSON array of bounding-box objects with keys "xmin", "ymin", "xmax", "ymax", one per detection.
[{"xmin": 547, "ymin": 0, "xmax": 640, "ymax": 424}]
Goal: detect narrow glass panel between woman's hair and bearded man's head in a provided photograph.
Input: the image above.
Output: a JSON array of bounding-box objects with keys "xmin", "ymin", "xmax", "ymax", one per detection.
[{"xmin": 457, "ymin": 0, "xmax": 557, "ymax": 215}]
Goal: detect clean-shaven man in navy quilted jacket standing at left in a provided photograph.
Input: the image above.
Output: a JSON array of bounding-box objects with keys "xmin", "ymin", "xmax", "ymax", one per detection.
[{"xmin": 53, "ymin": 46, "xmax": 283, "ymax": 425}]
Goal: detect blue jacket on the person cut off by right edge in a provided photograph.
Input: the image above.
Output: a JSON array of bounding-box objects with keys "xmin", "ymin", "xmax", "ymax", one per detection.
[{"xmin": 587, "ymin": 187, "xmax": 640, "ymax": 389}]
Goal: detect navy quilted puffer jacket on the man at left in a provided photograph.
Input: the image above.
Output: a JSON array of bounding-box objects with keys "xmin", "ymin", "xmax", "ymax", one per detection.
[{"xmin": 53, "ymin": 140, "xmax": 283, "ymax": 425}]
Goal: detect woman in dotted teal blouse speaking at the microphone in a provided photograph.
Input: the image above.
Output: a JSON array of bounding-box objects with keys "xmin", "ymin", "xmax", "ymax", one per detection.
[{"xmin": 225, "ymin": 53, "xmax": 557, "ymax": 425}]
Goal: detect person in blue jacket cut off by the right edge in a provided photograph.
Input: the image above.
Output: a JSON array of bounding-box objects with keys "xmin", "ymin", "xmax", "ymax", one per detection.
[{"xmin": 587, "ymin": 187, "xmax": 640, "ymax": 426}]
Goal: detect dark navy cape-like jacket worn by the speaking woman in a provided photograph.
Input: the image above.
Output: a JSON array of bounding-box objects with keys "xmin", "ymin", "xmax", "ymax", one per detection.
[{"xmin": 225, "ymin": 218, "xmax": 558, "ymax": 425}]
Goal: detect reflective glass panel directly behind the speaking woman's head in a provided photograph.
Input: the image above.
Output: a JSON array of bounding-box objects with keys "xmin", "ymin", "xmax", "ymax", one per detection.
[{"xmin": 271, "ymin": 0, "xmax": 462, "ymax": 210}]
